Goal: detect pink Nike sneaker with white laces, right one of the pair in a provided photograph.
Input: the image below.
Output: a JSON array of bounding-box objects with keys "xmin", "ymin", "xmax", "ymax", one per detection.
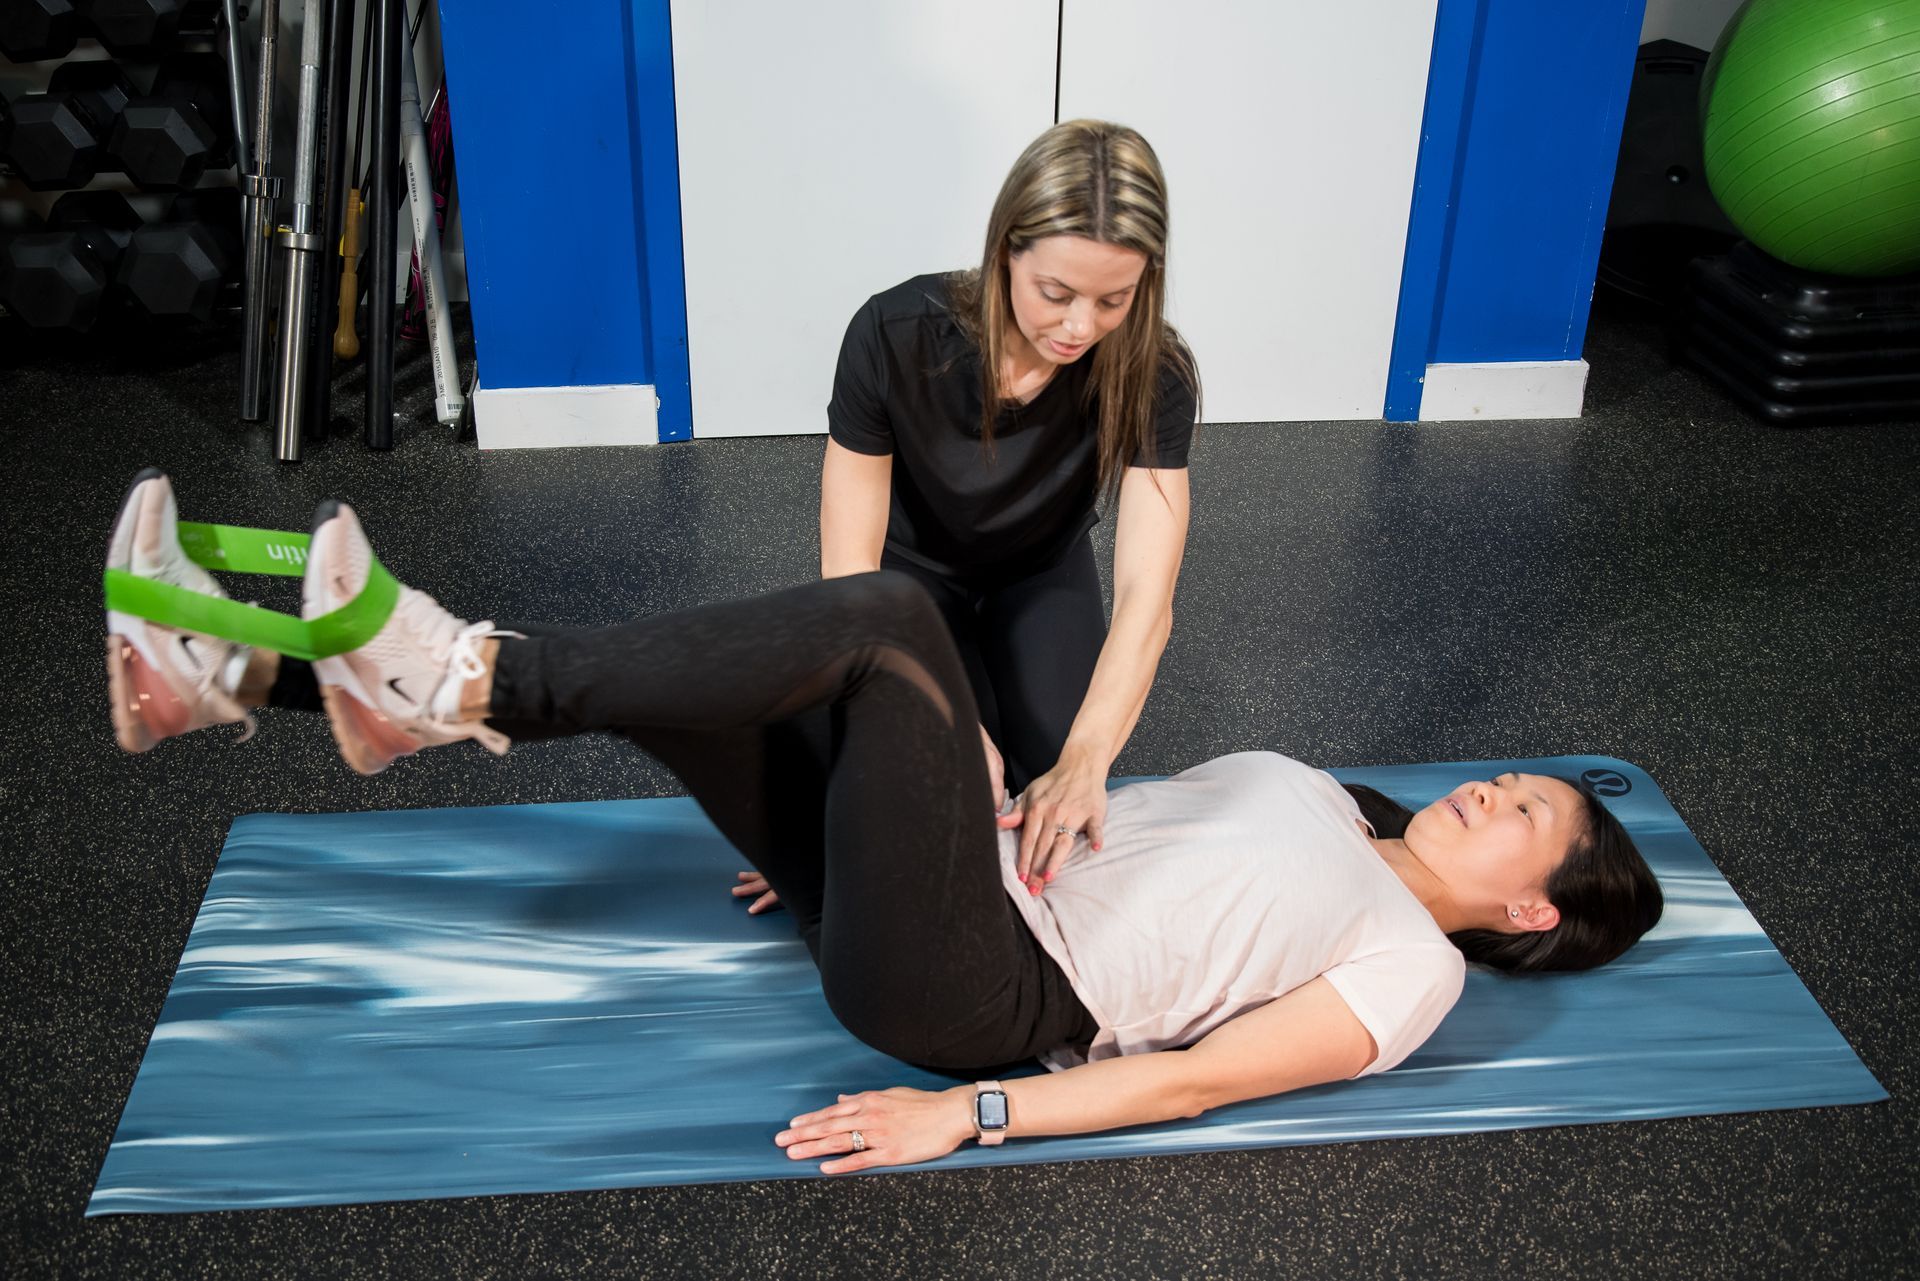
[{"xmin": 300, "ymin": 499, "xmax": 516, "ymax": 774}]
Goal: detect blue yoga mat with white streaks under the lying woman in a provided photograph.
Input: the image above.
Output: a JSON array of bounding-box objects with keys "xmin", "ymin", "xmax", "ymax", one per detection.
[{"xmin": 86, "ymin": 757, "xmax": 1887, "ymax": 1214}]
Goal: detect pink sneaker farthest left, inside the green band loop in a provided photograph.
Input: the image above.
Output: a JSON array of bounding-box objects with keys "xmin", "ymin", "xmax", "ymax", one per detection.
[{"xmin": 108, "ymin": 467, "xmax": 253, "ymax": 751}]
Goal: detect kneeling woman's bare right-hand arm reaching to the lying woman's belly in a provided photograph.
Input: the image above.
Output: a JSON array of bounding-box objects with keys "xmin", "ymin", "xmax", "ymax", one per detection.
[{"xmin": 1018, "ymin": 467, "xmax": 1188, "ymax": 880}]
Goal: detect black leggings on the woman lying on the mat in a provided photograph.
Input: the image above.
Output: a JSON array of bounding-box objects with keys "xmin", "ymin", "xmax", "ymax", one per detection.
[{"xmin": 271, "ymin": 572, "xmax": 1096, "ymax": 1070}]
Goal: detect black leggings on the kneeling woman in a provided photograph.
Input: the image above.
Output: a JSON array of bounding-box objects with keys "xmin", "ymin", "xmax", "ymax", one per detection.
[{"xmin": 881, "ymin": 536, "xmax": 1106, "ymax": 795}]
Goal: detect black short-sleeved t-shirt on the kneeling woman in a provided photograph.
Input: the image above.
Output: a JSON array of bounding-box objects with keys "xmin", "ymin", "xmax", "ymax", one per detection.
[{"xmin": 828, "ymin": 275, "xmax": 1194, "ymax": 578}]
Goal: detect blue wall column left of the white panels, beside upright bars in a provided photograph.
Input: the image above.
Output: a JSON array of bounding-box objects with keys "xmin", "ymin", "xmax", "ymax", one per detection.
[{"xmin": 440, "ymin": 0, "xmax": 693, "ymax": 440}]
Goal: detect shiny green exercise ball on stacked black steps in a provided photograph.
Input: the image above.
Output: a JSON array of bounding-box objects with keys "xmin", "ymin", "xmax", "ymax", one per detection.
[{"xmin": 1701, "ymin": 0, "xmax": 1920, "ymax": 277}]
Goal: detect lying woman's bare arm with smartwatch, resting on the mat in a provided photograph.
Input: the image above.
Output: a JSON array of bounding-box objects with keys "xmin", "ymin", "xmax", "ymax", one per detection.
[{"xmin": 774, "ymin": 978, "xmax": 1379, "ymax": 1173}]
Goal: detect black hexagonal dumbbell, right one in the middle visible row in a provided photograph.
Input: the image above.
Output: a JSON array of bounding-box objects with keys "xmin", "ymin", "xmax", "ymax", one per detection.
[{"xmin": 108, "ymin": 54, "xmax": 232, "ymax": 190}]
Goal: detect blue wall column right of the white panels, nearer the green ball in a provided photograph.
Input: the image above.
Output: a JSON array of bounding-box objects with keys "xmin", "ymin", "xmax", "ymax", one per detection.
[{"xmin": 1384, "ymin": 0, "xmax": 1645, "ymax": 421}]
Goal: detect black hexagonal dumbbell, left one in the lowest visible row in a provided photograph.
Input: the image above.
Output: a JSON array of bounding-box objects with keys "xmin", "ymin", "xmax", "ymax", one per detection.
[{"xmin": 0, "ymin": 192, "xmax": 140, "ymax": 332}]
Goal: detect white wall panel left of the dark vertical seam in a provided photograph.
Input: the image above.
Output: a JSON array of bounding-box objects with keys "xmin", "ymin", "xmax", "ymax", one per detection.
[{"xmin": 672, "ymin": 0, "xmax": 1060, "ymax": 436}]
